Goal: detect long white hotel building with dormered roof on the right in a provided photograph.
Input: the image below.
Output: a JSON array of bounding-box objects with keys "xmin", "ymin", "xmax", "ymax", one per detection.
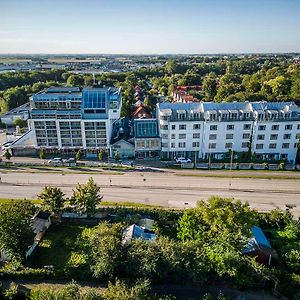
[{"xmin": 157, "ymin": 101, "xmax": 300, "ymax": 163}]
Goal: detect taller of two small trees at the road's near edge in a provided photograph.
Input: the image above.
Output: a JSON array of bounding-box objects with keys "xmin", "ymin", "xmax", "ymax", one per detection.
[{"xmin": 70, "ymin": 177, "xmax": 103, "ymax": 216}]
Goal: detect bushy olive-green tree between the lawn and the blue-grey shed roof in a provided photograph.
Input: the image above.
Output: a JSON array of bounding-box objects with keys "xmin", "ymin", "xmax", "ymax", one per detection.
[{"xmin": 90, "ymin": 223, "xmax": 123, "ymax": 279}]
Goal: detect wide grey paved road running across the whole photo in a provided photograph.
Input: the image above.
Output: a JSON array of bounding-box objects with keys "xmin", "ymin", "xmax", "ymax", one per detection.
[{"xmin": 0, "ymin": 172, "xmax": 300, "ymax": 216}]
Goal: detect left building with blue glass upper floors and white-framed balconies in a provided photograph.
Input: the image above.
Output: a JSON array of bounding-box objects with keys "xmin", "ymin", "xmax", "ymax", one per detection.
[{"xmin": 30, "ymin": 87, "xmax": 122, "ymax": 153}]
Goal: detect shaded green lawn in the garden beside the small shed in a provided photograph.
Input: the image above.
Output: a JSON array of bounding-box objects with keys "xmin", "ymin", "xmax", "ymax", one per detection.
[{"xmin": 32, "ymin": 225, "xmax": 87, "ymax": 277}]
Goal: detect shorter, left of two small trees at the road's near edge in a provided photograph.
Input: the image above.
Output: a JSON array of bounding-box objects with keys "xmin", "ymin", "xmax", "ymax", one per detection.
[{"xmin": 37, "ymin": 186, "xmax": 65, "ymax": 214}]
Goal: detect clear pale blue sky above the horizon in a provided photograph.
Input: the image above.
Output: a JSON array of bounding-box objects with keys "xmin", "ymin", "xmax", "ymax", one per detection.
[{"xmin": 0, "ymin": 0, "xmax": 300, "ymax": 54}]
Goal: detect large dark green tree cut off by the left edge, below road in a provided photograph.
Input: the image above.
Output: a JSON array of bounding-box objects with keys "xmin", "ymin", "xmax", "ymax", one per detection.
[{"xmin": 0, "ymin": 200, "xmax": 35, "ymax": 263}]
